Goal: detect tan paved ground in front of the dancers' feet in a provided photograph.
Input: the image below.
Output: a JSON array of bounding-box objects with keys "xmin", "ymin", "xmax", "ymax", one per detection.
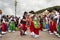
[{"xmin": 0, "ymin": 31, "xmax": 60, "ymax": 40}]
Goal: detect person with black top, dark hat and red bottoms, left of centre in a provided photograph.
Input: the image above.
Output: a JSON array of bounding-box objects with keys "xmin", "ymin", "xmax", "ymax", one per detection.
[{"xmin": 20, "ymin": 12, "xmax": 27, "ymax": 36}]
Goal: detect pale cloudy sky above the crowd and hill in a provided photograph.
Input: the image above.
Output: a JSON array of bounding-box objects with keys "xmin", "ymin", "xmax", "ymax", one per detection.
[{"xmin": 0, "ymin": 0, "xmax": 60, "ymax": 16}]
